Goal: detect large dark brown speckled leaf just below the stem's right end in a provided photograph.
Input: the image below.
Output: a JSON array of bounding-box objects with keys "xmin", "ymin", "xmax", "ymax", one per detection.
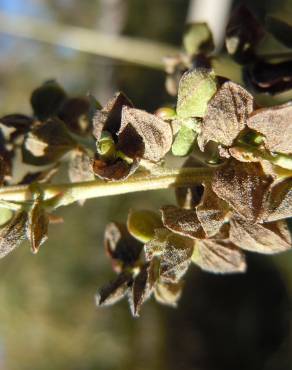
[{"xmin": 212, "ymin": 160, "xmax": 273, "ymax": 221}]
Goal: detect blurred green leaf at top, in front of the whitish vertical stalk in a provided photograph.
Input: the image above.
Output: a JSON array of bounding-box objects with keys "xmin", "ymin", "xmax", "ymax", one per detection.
[{"xmin": 183, "ymin": 23, "xmax": 214, "ymax": 55}]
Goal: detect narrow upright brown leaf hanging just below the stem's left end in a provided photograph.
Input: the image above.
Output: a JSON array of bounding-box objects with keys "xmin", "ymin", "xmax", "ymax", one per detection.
[{"xmin": 27, "ymin": 200, "xmax": 49, "ymax": 253}]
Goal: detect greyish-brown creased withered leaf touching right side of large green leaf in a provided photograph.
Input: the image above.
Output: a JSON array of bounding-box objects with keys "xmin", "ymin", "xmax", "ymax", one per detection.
[{"xmin": 198, "ymin": 81, "xmax": 253, "ymax": 151}]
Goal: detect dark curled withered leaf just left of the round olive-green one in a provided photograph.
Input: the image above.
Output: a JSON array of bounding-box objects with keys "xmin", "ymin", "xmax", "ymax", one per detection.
[{"xmin": 104, "ymin": 222, "xmax": 143, "ymax": 270}]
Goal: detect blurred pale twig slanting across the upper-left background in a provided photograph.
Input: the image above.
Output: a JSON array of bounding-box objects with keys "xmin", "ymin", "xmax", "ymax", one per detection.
[{"xmin": 0, "ymin": 11, "xmax": 179, "ymax": 69}]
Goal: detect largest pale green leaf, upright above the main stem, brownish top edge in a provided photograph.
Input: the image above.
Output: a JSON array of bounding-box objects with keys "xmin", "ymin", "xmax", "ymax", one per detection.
[{"xmin": 177, "ymin": 68, "xmax": 217, "ymax": 118}]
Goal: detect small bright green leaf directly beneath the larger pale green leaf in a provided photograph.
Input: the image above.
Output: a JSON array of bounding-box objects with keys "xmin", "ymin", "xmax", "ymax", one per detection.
[{"xmin": 171, "ymin": 125, "xmax": 197, "ymax": 157}]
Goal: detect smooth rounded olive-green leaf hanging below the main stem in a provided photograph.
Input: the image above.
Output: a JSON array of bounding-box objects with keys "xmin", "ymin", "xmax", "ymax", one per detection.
[{"xmin": 127, "ymin": 210, "xmax": 162, "ymax": 243}]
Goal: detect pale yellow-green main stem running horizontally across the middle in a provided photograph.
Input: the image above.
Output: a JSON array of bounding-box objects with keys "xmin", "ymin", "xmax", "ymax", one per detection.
[{"xmin": 0, "ymin": 168, "xmax": 214, "ymax": 208}]
